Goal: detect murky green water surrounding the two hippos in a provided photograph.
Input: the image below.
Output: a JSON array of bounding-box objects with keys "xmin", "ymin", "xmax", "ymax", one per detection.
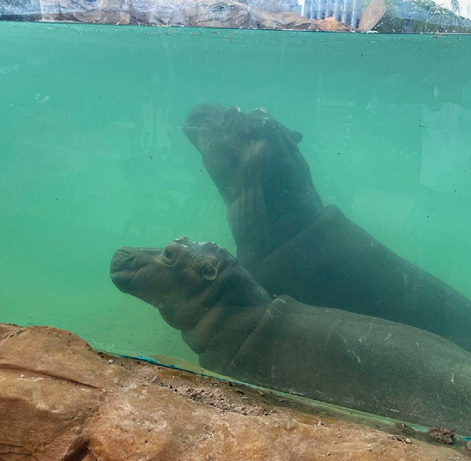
[{"xmin": 0, "ymin": 22, "xmax": 471, "ymax": 360}]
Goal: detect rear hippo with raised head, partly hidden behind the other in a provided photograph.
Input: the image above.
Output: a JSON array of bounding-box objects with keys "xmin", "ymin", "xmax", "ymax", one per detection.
[{"xmin": 184, "ymin": 105, "xmax": 471, "ymax": 351}]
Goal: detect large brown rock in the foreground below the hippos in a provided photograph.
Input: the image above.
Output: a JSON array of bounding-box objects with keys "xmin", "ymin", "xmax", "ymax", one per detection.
[{"xmin": 0, "ymin": 324, "xmax": 466, "ymax": 461}]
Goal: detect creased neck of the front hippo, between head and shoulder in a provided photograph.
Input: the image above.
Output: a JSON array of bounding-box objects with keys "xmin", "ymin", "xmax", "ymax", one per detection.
[{"xmin": 182, "ymin": 264, "xmax": 272, "ymax": 360}]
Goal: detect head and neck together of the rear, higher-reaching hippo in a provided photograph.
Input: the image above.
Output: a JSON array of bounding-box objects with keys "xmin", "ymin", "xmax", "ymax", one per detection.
[{"xmin": 183, "ymin": 104, "xmax": 323, "ymax": 270}]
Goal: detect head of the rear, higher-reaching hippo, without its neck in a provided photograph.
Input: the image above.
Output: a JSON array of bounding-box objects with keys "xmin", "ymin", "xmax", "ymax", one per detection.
[{"xmin": 183, "ymin": 104, "xmax": 304, "ymax": 205}]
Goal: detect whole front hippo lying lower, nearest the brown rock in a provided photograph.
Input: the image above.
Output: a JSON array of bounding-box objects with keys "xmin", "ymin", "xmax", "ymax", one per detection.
[{"xmin": 110, "ymin": 238, "xmax": 471, "ymax": 434}]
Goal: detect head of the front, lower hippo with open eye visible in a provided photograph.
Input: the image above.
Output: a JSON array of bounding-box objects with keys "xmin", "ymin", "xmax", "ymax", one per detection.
[{"xmin": 110, "ymin": 237, "xmax": 238, "ymax": 330}]
